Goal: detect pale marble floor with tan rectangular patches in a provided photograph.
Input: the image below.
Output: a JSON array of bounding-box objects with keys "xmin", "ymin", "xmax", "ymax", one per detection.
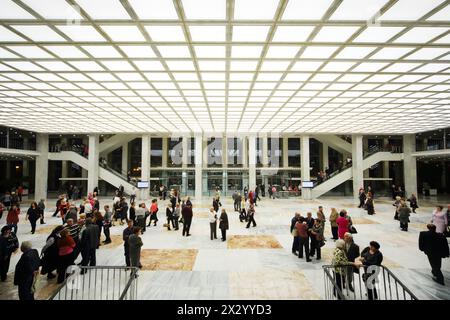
[{"xmin": 0, "ymin": 197, "xmax": 450, "ymax": 300}]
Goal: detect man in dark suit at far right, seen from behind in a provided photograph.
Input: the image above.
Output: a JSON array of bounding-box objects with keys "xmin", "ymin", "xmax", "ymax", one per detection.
[{"xmin": 419, "ymin": 224, "xmax": 449, "ymax": 285}]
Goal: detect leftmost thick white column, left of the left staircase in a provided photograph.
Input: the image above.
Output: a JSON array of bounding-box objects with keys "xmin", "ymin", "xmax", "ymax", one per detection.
[{"xmin": 34, "ymin": 133, "xmax": 48, "ymax": 201}]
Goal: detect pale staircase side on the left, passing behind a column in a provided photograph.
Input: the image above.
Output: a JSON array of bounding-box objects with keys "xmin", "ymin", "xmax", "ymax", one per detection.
[{"xmin": 48, "ymin": 151, "xmax": 135, "ymax": 194}]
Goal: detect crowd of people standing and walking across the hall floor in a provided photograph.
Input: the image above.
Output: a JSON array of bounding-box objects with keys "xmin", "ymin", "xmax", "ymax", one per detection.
[{"xmin": 0, "ymin": 180, "xmax": 450, "ymax": 300}]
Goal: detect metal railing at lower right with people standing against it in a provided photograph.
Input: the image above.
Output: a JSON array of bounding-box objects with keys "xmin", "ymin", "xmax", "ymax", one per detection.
[{"xmin": 322, "ymin": 265, "xmax": 418, "ymax": 300}]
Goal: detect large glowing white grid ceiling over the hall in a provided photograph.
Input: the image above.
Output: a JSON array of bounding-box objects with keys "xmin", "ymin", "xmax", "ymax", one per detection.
[{"xmin": 0, "ymin": 0, "xmax": 450, "ymax": 134}]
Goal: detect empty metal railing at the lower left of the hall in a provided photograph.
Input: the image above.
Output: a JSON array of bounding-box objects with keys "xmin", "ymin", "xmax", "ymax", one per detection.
[{"xmin": 50, "ymin": 266, "xmax": 138, "ymax": 300}]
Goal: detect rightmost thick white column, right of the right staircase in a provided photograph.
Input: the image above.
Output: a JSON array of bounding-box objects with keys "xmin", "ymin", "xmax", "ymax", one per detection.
[{"xmin": 403, "ymin": 134, "xmax": 417, "ymax": 197}]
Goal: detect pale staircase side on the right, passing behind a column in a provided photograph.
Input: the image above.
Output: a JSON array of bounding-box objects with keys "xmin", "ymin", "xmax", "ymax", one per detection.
[{"xmin": 312, "ymin": 151, "xmax": 403, "ymax": 198}]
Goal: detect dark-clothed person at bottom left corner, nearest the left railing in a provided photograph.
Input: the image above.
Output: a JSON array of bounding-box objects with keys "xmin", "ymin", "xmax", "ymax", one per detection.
[{"xmin": 14, "ymin": 241, "xmax": 40, "ymax": 300}]
